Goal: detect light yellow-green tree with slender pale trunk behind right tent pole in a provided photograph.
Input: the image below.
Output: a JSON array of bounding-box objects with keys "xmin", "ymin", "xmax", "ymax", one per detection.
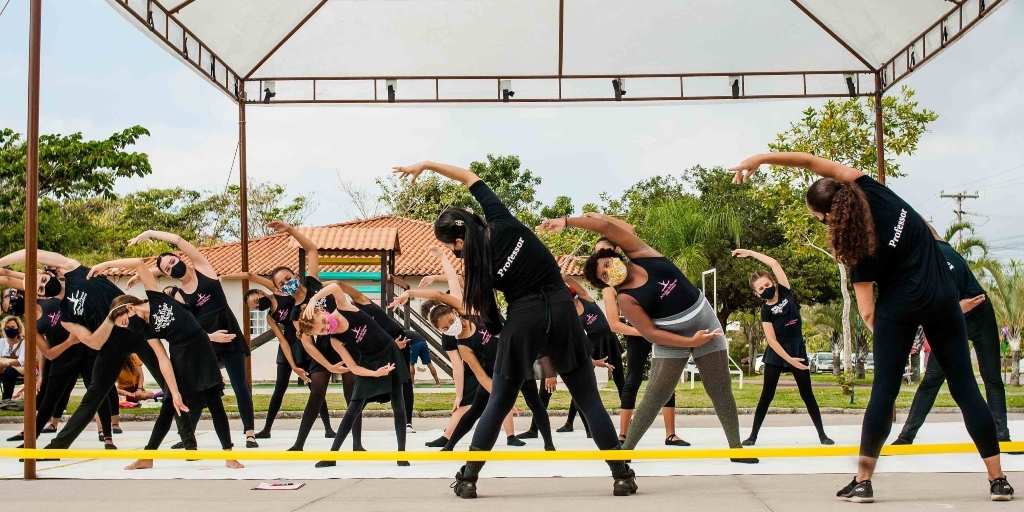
[{"xmin": 761, "ymin": 86, "xmax": 938, "ymax": 378}]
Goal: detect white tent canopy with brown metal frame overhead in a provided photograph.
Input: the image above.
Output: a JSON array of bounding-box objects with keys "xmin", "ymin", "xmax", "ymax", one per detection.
[{"xmin": 108, "ymin": 0, "xmax": 1004, "ymax": 103}]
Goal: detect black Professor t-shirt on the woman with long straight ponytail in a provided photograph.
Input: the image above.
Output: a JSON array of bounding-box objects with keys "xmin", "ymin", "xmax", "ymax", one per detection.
[{"xmin": 469, "ymin": 181, "xmax": 565, "ymax": 315}]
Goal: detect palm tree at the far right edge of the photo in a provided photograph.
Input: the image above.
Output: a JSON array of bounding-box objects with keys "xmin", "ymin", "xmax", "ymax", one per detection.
[{"xmin": 985, "ymin": 261, "xmax": 1024, "ymax": 386}]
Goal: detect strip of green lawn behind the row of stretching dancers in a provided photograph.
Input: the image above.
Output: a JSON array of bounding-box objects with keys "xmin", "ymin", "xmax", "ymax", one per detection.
[{"xmin": 0, "ymin": 376, "xmax": 1024, "ymax": 416}]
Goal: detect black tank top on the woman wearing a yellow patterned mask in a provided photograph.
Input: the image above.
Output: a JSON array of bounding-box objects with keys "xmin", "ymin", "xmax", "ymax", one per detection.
[{"xmin": 616, "ymin": 256, "xmax": 700, "ymax": 318}]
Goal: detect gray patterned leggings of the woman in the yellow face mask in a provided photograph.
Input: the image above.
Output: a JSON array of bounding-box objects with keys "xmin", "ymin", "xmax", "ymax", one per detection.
[{"xmin": 623, "ymin": 350, "xmax": 741, "ymax": 450}]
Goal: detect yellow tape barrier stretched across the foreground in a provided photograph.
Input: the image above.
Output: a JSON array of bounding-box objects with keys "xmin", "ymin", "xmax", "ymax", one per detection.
[{"xmin": 0, "ymin": 441, "xmax": 1024, "ymax": 462}]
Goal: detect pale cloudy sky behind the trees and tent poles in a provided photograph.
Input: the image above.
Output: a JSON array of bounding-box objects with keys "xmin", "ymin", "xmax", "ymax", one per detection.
[{"xmin": 0, "ymin": 0, "xmax": 1024, "ymax": 258}]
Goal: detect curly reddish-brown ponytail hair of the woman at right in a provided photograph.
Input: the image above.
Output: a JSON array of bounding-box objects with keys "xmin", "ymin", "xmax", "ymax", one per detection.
[{"xmin": 807, "ymin": 178, "xmax": 876, "ymax": 266}]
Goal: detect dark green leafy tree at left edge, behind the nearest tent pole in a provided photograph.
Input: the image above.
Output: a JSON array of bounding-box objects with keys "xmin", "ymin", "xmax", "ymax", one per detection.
[{"xmin": 0, "ymin": 126, "xmax": 153, "ymax": 252}]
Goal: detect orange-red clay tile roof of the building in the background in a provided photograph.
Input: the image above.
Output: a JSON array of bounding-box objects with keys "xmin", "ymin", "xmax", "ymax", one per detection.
[{"xmin": 105, "ymin": 215, "xmax": 585, "ymax": 278}]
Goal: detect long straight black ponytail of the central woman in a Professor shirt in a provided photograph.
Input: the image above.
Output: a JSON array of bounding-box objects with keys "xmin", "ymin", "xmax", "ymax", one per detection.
[{"xmin": 434, "ymin": 208, "xmax": 495, "ymax": 319}]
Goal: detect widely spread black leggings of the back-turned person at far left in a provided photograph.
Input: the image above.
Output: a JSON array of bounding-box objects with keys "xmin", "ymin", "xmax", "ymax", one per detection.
[{"xmin": 48, "ymin": 342, "xmax": 196, "ymax": 449}]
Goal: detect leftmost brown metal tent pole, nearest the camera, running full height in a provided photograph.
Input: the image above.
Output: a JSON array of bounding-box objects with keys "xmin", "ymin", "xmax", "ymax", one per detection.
[{"xmin": 24, "ymin": 0, "xmax": 43, "ymax": 480}]
